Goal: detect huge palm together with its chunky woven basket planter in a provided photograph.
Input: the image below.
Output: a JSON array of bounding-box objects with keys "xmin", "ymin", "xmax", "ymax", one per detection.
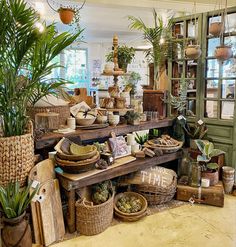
[{"xmin": 0, "ymin": 0, "xmax": 82, "ymax": 185}]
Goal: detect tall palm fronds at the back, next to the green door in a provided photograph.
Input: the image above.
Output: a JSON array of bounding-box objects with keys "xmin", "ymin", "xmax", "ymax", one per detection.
[{"xmin": 128, "ymin": 9, "xmax": 175, "ymax": 87}]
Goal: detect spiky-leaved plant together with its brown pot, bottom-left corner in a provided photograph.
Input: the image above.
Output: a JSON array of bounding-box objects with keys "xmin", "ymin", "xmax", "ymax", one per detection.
[{"xmin": 0, "ymin": 181, "xmax": 38, "ymax": 247}]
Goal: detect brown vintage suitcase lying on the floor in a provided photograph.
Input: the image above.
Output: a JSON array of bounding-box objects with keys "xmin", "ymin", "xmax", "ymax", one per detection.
[{"xmin": 176, "ymin": 182, "xmax": 224, "ymax": 207}]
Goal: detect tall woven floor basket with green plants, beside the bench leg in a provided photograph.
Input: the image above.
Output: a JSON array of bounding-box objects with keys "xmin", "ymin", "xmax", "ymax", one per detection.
[{"xmin": 75, "ymin": 181, "xmax": 114, "ymax": 236}]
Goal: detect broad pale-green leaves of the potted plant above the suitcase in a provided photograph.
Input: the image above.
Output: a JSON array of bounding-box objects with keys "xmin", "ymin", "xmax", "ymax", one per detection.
[{"xmin": 195, "ymin": 140, "xmax": 225, "ymax": 163}]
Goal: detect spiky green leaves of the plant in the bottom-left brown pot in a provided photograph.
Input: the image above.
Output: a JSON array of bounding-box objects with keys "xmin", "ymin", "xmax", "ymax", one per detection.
[{"xmin": 0, "ymin": 181, "xmax": 38, "ymax": 219}]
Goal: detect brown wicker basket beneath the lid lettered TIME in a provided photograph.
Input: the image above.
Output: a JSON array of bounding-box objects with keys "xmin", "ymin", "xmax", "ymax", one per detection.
[{"xmin": 133, "ymin": 176, "xmax": 177, "ymax": 205}]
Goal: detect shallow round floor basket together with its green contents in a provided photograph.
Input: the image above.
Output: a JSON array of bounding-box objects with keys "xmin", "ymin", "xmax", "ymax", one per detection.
[{"xmin": 114, "ymin": 192, "xmax": 147, "ymax": 221}]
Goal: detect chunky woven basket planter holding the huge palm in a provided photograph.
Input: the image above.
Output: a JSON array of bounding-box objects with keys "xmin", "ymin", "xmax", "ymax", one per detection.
[{"xmin": 0, "ymin": 127, "xmax": 34, "ymax": 186}]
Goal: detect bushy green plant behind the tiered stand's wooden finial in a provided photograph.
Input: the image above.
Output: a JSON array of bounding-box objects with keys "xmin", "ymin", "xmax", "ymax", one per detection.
[{"xmin": 106, "ymin": 45, "xmax": 135, "ymax": 73}]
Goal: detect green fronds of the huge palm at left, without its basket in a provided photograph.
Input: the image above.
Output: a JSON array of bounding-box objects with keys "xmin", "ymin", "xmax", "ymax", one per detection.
[{"xmin": 0, "ymin": 0, "xmax": 82, "ymax": 137}]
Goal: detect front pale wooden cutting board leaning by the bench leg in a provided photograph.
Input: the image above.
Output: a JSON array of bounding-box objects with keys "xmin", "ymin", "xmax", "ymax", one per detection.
[{"xmin": 38, "ymin": 179, "xmax": 65, "ymax": 246}]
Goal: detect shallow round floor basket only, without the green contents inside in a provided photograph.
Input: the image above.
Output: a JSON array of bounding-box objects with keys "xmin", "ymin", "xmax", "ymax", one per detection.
[{"xmin": 114, "ymin": 192, "xmax": 148, "ymax": 217}]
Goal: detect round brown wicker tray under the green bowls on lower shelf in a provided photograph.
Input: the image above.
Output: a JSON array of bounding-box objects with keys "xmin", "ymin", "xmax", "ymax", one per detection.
[{"xmin": 55, "ymin": 152, "xmax": 100, "ymax": 173}]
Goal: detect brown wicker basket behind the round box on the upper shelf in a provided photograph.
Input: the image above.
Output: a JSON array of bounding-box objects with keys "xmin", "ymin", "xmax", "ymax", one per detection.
[{"xmin": 27, "ymin": 105, "xmax": 70, "ymax": 125}]
